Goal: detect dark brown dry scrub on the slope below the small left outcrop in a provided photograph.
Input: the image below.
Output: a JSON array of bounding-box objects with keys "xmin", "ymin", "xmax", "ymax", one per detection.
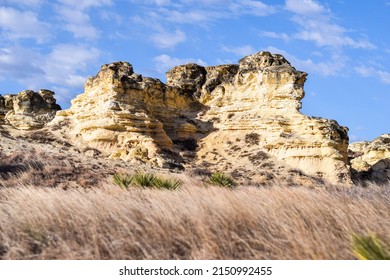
[{"xmin": 0, "ymin": 150, "xmax": 115, "ymax": 189}]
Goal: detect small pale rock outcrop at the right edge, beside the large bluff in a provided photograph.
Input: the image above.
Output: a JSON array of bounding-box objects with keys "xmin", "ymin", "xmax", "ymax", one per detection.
[{"xmin": 349, "ymin": 134, "xmax": 390, "ymax": 183}]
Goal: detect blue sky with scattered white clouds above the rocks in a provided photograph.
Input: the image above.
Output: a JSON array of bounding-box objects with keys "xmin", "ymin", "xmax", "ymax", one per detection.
[{"xmin": 0, "ymin": 0, "xmax": 390, "ymax": 141}]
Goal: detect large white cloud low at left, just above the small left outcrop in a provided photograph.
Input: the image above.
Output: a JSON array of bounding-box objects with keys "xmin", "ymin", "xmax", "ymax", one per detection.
[{"xmin": 0, "ymin": 44, "xmax": 100, "ymax": 94}]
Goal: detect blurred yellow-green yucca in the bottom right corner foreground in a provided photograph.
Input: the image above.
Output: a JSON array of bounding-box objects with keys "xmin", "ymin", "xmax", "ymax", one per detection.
[{"xmin": 352, "ymin": 235, "xmax": 390, "ymax": 260}]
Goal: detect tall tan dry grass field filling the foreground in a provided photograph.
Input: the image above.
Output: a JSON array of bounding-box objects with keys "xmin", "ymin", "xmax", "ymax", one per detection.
[{"xmin": 0, "ymin": 177, "xmax": 390, "ymax": 259}]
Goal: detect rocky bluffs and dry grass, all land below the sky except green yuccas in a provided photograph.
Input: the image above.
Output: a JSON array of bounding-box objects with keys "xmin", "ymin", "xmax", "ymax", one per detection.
[{"xmin": 0, "ymin": 52, "xmax": 390, "ymax": 259}]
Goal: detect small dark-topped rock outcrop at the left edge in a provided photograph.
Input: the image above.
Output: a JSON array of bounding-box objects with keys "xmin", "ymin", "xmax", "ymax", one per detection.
[{"xmin": 0, "ymin": 89, "xmax": 61, "ymax": 130}]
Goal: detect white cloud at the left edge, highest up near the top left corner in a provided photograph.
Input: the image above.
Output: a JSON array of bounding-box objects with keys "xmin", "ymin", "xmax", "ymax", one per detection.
[{"xmin": 0, "ymin": 7, "xmax": 50, "ymax": 43}]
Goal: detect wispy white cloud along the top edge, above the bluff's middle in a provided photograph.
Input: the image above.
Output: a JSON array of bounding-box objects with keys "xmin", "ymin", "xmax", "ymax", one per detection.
[{"xmin": 130, "ymin": 0, "xmax": 276, "ymax": 48}]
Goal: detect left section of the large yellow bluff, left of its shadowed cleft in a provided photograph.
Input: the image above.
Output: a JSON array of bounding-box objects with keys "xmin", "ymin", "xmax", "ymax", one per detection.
[{"xmin": 51, "ymin": 62, "xmax": 193, "ymax": 167}]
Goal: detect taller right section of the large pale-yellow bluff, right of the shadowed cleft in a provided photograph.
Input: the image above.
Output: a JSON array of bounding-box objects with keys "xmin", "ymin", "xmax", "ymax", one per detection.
[{"xmin": 192, "ymin": 52, "xmax": 350, "ymax": 182}]
